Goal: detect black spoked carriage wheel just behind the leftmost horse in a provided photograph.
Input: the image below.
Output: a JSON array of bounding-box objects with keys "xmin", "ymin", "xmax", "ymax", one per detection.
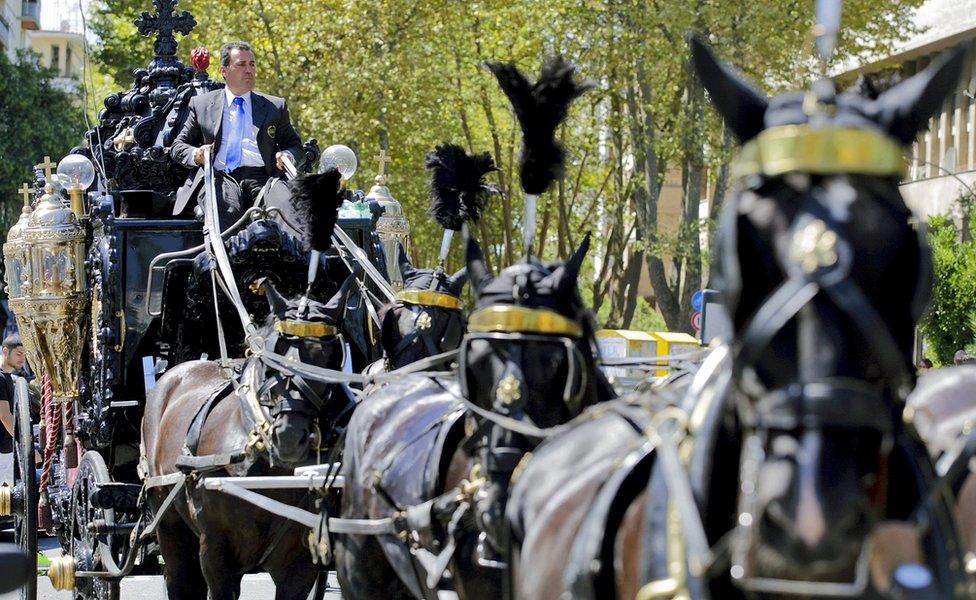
[{"xmin": 71, "ymin": 450, "xmax": 124, "ymax": 600}]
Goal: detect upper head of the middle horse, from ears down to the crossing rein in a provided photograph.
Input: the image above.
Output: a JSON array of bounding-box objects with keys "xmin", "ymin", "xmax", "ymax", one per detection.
[{"xmin": 460, "ymin": 236, "xmax": 601, "ymax": 427}]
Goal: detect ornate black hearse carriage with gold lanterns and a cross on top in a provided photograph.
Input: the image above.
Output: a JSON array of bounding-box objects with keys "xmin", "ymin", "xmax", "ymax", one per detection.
[{"xmin": 0, "ymin": 0, "xmax": 386, "ymax": 599}]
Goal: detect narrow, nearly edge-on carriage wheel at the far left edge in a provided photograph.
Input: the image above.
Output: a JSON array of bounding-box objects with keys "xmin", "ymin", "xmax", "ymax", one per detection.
[{"xmin": 13, "ymin": 379, "xmax": 38, "ymax": 600}]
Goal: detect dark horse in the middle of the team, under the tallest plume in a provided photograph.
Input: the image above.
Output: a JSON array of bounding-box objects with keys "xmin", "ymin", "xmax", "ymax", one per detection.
[{"xmin": 336, "ymin": 233, "xmax": 613, "ymax": 598}]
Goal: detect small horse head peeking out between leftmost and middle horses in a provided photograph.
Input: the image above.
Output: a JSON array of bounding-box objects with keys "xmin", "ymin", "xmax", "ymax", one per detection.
[{"xmin": 380, "ymin": 246, "xmax": 467, "ymax": 369}]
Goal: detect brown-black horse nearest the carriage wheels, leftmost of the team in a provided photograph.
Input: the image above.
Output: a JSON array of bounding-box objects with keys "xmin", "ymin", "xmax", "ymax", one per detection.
[{"xmin": 142, "ymin": 276, "xmax": 352, "ymax": 599}]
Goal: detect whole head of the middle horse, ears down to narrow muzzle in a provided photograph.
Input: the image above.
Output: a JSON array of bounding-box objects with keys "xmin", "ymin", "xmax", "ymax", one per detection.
[{"xmin": 458, "ymin": 236, "xmax": 612, "ymax": 556}]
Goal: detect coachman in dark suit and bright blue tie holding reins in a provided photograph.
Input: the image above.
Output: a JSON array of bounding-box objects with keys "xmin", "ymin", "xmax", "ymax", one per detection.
[{"xmin": 170, "ymin": 42, "xmax": 301, "ymax": 229}]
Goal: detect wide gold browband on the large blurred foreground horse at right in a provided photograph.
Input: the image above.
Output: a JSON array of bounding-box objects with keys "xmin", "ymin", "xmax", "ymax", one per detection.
[{"xmin": 732, "ymin": 125, "xmax": 905, "ymax": 179}]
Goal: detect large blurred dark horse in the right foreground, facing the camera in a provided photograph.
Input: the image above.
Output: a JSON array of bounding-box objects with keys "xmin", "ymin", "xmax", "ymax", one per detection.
[{"xmin": 509, "ymin": 40, "xmax": 965, "ymax": 598}]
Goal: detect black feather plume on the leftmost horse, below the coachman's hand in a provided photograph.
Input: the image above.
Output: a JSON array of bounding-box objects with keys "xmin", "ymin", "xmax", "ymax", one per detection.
[{"xmin": 292, "ymin": 169, "xmax": 342, "ymax": 252}]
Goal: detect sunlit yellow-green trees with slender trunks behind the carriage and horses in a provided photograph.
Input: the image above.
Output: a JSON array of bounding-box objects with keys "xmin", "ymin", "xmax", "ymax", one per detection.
[{"xmin": 92, "ymin": 0, "xmax": 922, "ymax": 331}]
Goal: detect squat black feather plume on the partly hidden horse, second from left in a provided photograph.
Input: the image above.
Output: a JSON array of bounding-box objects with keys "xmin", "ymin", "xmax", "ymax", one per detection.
[{"xmin": 424, "ymin": 144, "xmax": 498, "ymax": 231}]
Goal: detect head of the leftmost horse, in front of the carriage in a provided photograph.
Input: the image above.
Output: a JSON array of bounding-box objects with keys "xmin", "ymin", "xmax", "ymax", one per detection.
[{"xmin": 260, "ymin": 275, "xmax": 353, "ymax": 465}]
